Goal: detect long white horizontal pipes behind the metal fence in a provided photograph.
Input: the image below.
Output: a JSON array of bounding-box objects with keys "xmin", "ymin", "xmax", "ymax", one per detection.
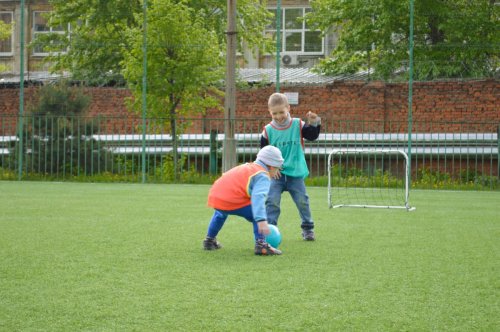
[{"xmin": 0, "ymin": 133, "xmax": 499, "ymax": 158}]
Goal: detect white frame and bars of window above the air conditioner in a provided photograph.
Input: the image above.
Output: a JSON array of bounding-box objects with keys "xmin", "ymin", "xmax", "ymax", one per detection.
[{"xmin": 265, "ymin": 6, "xmax": 325, "ymax": 55}]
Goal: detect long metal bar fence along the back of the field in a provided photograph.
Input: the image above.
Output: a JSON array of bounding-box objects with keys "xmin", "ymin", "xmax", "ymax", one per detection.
[{"xmin": 0, "ymin": 115, "xmax": 500, "ymax": 189}]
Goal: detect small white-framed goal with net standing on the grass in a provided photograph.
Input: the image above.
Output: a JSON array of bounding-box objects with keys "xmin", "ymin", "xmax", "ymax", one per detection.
[{"xmin": 328, "ymin": 148, "xmax": 415, "ymax": 211}]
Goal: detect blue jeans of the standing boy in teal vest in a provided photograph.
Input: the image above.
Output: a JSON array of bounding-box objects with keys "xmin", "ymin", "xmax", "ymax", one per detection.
[{"xmin": 266, "ymin": 174, "xmax": 314, "ymax": 230}]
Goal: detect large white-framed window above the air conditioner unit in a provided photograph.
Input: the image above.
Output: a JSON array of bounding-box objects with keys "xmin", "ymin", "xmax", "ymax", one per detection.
[{"xmin": 266, "ymin": 7, "xmax": 324, "ymax": 54}]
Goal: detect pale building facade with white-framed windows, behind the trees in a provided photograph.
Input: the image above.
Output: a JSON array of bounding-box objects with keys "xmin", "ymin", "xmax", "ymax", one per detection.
[{"xmin": 0, "ymin": 0, "xmax": 336, "ymax": 79}]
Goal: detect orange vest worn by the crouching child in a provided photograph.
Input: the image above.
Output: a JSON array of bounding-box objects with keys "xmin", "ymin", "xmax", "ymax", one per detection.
[{"xmin": 208, "ymin": 163, "xmax": 268, "ymax": 211}]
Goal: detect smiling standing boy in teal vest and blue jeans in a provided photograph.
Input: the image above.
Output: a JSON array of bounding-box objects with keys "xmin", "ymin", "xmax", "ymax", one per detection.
[{"xmin": 260, "ymin": 93, "xmax": 321, "ymax": 241}]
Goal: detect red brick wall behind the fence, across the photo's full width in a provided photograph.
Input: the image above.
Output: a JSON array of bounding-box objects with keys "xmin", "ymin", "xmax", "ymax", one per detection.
[{"xmin": 0, "ymin": 79, "xmax": 500, "ymax": 132}]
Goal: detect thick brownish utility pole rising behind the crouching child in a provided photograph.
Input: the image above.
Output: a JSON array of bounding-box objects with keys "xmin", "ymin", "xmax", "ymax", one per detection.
[{"xmin": 222, "ymin": 0, "xmax": 237, "ymax": 172}]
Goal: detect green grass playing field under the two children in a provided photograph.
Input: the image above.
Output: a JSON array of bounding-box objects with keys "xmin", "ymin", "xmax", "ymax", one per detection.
[{"xmin": 0, "ymin": 181, "xmax": 500, "ymax": 331}]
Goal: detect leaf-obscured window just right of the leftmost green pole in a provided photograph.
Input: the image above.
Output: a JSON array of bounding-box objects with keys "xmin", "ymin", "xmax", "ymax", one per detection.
[{"xmin": 33, "ymin": 12, "xmax": 69, "ymax": 55}]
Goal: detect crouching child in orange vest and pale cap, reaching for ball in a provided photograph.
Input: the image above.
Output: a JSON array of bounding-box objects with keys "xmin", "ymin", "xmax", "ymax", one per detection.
[{"xmin": 203, "ymin": 146, "xmax": 283, "ymax": 256}]
